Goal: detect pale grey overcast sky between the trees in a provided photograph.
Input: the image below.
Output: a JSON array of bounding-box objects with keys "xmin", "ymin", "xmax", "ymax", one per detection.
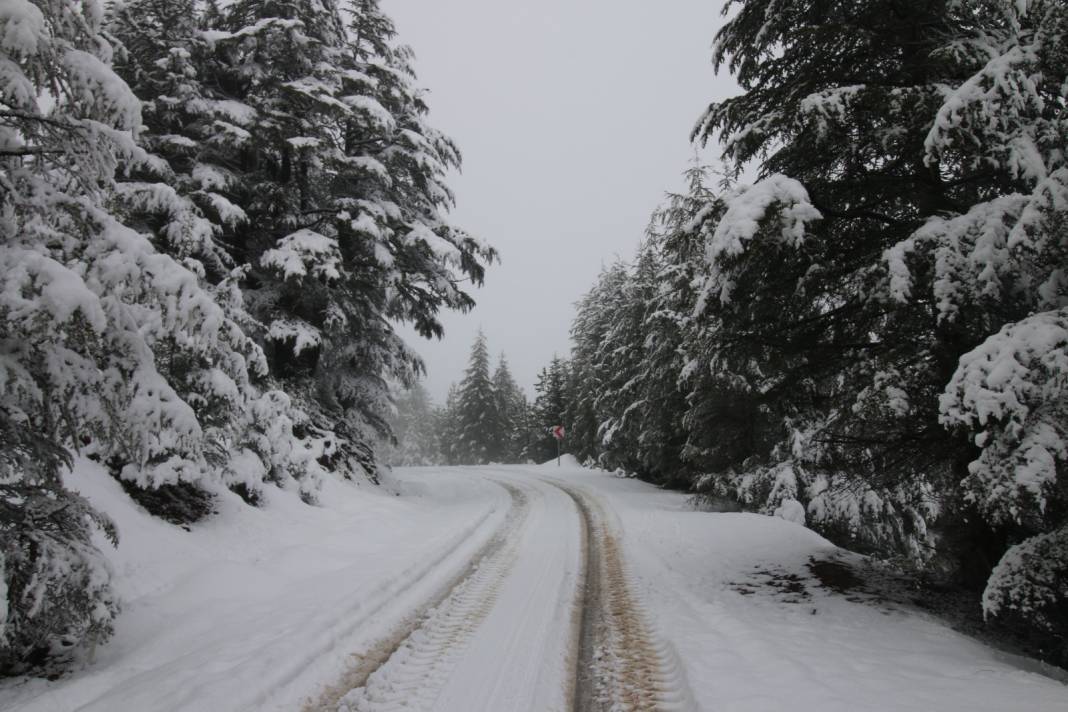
[{"xmin": 382, "ymin": 0, "xmax": 736, "ymax": 402}]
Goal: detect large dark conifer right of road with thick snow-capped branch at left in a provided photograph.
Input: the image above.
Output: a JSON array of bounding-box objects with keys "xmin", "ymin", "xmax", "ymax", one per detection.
[{"xmin": 697, "ymin": 0, "xmax": 990, "ymax": 559}]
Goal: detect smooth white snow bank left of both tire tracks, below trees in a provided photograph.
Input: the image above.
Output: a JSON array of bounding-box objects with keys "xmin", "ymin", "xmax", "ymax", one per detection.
[{"xmin": 0, "ymin": 460, "xmax": 507, "ymax": 712}]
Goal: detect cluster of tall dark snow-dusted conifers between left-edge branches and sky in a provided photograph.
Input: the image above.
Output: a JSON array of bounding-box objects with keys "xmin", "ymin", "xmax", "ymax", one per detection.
[{"xmin": 112, "ymin": 0, "xmax": 493, "ymax": 484}]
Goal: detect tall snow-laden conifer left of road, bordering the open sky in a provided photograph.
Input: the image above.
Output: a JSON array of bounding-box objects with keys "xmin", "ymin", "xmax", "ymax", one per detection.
[{"xmin": 205, "ymin": 0, "xmax": 492, "ymax": 477}]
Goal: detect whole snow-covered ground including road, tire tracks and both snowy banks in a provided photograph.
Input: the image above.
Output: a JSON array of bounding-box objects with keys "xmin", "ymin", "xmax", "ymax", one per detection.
[{"xmin": 0, "ymin": 462, "xmax": 1068, "ymax": 712}]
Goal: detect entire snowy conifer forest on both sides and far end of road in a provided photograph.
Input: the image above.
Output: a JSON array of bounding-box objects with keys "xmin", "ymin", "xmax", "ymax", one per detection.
[{"xmin": 0, "ymin": 0, "xmax": 1068, "ymax": 675}]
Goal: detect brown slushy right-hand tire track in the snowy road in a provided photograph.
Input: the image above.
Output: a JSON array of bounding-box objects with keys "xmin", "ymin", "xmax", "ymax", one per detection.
[{"xmin": 545, "ymin": 479, "xmax": 697, "ymax": 712}]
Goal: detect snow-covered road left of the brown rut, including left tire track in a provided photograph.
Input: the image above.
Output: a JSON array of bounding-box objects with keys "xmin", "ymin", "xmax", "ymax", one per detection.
[{"xmin": 327, "ymin": 476, "xmax": 583, "ymax": 712}]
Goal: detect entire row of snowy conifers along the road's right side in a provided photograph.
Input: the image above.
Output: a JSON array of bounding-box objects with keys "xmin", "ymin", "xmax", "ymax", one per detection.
[{"xmin": 546, "ymin": 0, "xmax": 1068, "ymax": 664}]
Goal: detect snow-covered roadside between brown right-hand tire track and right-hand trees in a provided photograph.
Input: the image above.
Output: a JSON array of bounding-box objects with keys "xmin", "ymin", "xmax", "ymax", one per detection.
[{"xmin": 564, "ymin": 468, "xmax": 1068, "ymax": 712}]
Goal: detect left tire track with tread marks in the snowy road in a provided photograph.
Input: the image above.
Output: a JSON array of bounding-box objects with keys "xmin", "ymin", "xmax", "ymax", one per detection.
[{"xmin": 318, "ymin": 479, "xmax": 530, "ymax": 712}]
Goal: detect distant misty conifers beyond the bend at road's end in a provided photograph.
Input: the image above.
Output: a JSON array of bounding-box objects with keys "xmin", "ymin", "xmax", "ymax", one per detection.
[{"xmin": 386, "ymin": 332, "xmax": 568, "ymax": 465}]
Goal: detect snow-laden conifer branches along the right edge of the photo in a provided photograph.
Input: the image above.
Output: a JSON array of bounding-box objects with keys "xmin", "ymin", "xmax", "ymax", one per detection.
[{"xmin": 905, "ymin": 1, "xmax": 1068, "ymax": 665}]
